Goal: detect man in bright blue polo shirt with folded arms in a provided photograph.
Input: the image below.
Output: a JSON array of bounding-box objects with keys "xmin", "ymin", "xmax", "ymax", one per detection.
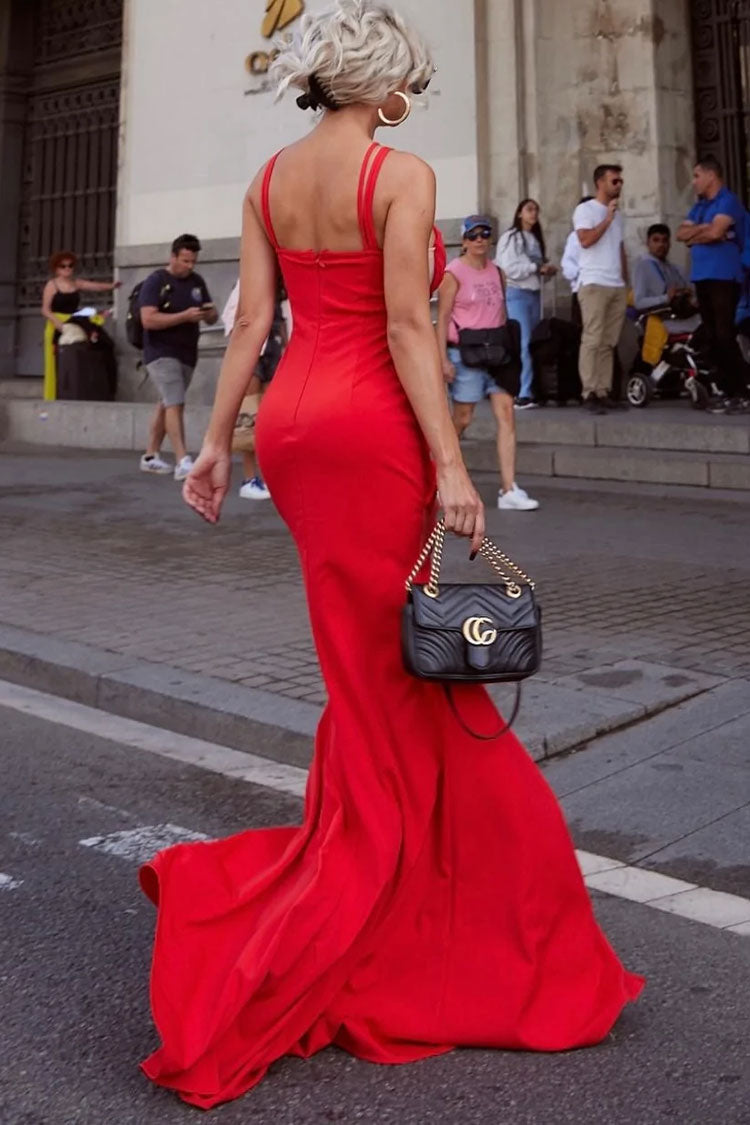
[{"xmin": 677, "ymin": 156, "xmax": 748, "ymax": 412}]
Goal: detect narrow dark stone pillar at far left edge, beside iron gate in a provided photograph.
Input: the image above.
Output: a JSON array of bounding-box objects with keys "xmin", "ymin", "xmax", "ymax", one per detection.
[{"xmin": 0, "ymin": 0, "xmax": 33, "ymax": 378}]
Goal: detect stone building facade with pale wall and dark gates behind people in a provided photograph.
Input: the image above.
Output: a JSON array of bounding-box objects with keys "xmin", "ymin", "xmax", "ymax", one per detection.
[{"xmin": 0, "ymin": 0, "xmax": 750, "ymax": 399}]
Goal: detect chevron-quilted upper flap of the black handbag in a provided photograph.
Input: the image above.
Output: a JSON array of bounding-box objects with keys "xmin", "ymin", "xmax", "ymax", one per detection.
[{"xmin": 410, "ymin": 583, "xmax": 540, "ymax": 632}]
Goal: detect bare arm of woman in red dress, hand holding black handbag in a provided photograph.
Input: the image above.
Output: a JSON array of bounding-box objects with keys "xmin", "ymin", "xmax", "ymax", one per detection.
[{"xmin": 381, "ymin": 153, "xmax": 485, "ymax": 550}]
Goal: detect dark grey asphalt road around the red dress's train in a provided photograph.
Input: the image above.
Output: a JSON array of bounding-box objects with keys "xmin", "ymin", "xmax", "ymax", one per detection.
[{"xmin": 0, "ymin": 709, "xmax": 750, "ymax": 1125}]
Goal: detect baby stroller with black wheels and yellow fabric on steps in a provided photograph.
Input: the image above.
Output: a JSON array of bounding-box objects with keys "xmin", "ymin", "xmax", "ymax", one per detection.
[{"xmin": 625, "ymin": 305, "xmax": 717, "ymax": 411}]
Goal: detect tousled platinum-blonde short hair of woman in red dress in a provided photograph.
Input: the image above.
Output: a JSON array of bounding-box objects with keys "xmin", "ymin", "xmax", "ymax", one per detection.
[{"xmin": 271, "ymin": 0, "xmax": 435, "ymax": 108}]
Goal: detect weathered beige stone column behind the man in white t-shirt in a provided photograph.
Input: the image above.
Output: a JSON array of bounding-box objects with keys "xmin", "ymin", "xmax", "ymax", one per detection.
[{"xmin": 478, "ymin": 0, "xmax": 694, "ymax": 285}]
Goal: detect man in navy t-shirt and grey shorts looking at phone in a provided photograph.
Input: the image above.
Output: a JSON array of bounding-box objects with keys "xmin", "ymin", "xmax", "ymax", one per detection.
[{"xmin": 139, "ymin": 234, "xmax": 218, "ymax": 480}]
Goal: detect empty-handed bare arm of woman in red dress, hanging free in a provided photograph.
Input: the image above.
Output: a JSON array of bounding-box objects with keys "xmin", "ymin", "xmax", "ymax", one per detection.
[{"xmin": 182, "ymin": 173, "xmax": 278, "ymax": 523}]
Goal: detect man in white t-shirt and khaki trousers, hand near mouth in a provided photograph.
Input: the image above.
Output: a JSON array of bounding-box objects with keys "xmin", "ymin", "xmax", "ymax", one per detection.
[{"xmin": 573, "ymin": 164, "xmax": 627, "ymax": 414}]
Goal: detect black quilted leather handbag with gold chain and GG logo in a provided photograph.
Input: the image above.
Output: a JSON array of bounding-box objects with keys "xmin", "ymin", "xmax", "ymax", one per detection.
[{"xmin": 401, "ymin": 520, "xmax": 542, "ymax": 740}]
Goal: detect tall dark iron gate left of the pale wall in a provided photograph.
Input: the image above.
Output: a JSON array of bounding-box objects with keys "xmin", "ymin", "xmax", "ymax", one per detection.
[{"xmin": 18, "ymin": 0, "xmax": 123, "ymax": 308}]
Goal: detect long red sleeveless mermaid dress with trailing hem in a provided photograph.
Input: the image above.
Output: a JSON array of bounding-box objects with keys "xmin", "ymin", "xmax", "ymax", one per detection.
[{"xmin": 141, "ymin": 145, "xmax": 642, "ymax": 1108}]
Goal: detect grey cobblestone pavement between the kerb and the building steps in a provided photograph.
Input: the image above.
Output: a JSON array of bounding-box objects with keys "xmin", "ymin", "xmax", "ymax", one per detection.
[{"xmin": 0, "ymin": 453, "xmax": 750, "ymax": 703}]
